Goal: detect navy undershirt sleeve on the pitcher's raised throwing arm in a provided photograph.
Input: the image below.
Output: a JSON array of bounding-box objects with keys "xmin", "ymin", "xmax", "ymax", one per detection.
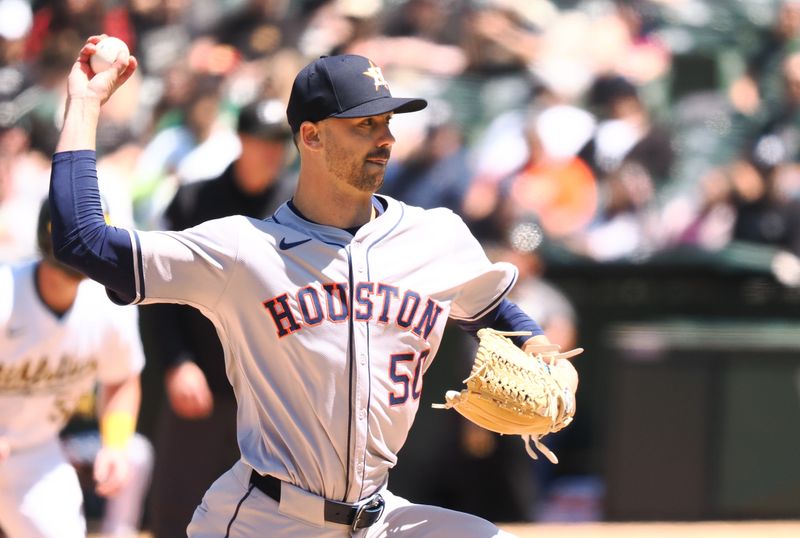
[{"xmin": 50, "ymin": 150, "xmax": 141, "ymax": 303}]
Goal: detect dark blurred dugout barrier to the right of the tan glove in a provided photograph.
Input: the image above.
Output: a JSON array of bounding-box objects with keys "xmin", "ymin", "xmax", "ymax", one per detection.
[{"xmin": 547, "ymin": 245, "xmax": 800, "ymax": 520}]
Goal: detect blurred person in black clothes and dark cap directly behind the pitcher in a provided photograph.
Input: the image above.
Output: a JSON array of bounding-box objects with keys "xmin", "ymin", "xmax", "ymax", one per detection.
[{"xmin": 141, "ymin": 99, "xmax": 296, "ymax": 538}]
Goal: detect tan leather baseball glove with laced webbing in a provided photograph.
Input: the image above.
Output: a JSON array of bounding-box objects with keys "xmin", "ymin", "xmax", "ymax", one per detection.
[{"xmin": 434, "ymin": 329, "xmax": 583, "ymax": 463}]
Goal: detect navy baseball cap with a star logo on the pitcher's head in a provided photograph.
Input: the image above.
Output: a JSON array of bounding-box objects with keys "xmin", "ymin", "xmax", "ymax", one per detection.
[{"xmin": 286, "ymin": 54, "xmax": 428, "ymax": 133}]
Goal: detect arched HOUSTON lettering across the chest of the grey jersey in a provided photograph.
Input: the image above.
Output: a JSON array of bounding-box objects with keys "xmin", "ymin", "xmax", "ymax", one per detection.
[{"xmin": 263, "ymin": 282, "xmax": 442, "ymax": 340}]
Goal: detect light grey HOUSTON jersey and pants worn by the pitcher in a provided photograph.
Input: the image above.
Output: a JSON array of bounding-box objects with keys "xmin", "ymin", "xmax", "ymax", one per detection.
[{"xmin": 119, "ymin": 196, "xmax": 517, "ymax": 537}]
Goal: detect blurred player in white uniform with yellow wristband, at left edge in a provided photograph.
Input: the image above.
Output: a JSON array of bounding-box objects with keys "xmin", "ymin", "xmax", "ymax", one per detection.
[{"xmin": 0, "ymin": 203, "xmax": 144, "ymax": 538}]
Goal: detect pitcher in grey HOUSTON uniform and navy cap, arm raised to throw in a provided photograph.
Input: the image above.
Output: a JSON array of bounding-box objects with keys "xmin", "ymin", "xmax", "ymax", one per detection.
[{"xmin": 50, "ymin": 36, "xmax": 577, "ymax": 537}]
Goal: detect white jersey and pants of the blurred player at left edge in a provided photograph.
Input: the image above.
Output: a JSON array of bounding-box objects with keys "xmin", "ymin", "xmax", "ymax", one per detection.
[{"xmin": 0, "ymin": 262, "xmax": 144, "ymax": 538}]
